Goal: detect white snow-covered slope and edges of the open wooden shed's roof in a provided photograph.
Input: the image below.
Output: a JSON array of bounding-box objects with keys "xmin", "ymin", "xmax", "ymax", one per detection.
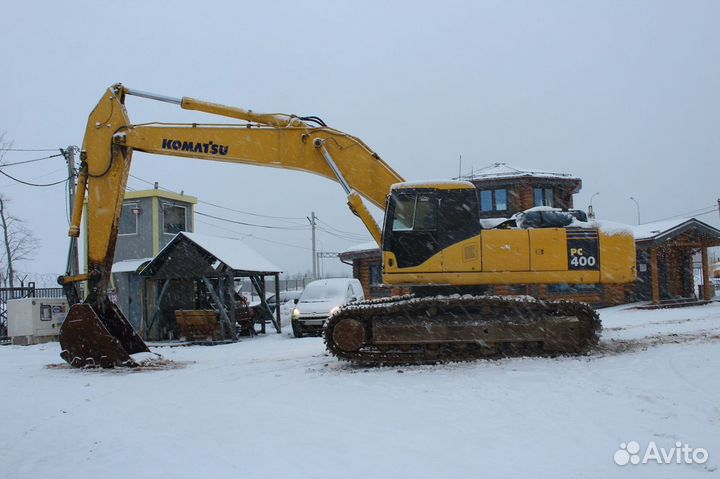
[{"xmin": 143, "ymin": 231, "xmax": 282, "ymax": 273}]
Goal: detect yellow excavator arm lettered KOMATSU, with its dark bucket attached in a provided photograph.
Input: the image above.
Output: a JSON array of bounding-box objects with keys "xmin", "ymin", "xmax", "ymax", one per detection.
[{"xmin": 60, "ymin": 84, "xmax": 403, "ymax": 365}]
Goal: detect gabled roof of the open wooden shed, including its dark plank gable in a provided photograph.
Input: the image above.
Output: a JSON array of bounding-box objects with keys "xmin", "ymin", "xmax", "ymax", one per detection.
[{"xmin": 140, "ymin": 231, "xmax": 282, "ymax": 276}]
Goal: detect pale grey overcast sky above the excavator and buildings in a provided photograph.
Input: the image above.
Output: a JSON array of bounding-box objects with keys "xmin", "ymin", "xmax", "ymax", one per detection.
[{"xmin": 0, "ymin": 0, "xmax": 720, "ymax": 284}]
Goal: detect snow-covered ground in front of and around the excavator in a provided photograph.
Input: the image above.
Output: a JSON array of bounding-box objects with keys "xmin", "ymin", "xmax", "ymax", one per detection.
[{"xmin": 0, "ymin": 303, "xmax": 720, "ymax": 478}]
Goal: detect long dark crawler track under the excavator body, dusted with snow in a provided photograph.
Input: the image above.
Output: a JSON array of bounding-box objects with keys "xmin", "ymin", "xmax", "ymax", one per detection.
[{"xmin": 323, "ymin": 295, "xmax": 601, "ymax": 365}]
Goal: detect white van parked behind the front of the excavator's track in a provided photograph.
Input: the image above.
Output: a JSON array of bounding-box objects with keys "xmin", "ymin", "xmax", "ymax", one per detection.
[{"xmin": 291, "ymin": 278, "xmax": 365, "ymax": 338}]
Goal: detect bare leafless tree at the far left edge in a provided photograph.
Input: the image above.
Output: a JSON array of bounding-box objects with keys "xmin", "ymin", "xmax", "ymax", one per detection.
[{"xmin": 0, "ymin": 134, "xmax": 40, "ymax": 288}]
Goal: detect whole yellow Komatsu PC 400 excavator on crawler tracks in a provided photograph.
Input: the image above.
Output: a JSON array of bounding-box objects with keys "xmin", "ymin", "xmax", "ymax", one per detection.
[{"xmin": 59, "ymin": 84, "xmax": 635, "ymax": 367}]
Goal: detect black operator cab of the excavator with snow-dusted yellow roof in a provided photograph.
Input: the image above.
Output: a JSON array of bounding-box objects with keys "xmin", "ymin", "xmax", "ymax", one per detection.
[{"xmin": 382, "ymin": 181, "xmax": 482, "ymax": 268}]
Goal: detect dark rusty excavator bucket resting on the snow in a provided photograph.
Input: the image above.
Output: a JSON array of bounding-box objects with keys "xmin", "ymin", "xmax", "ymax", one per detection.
[{"xmin": 60, "ymin": 301, "xmax": 150, "ymax": 368}]
